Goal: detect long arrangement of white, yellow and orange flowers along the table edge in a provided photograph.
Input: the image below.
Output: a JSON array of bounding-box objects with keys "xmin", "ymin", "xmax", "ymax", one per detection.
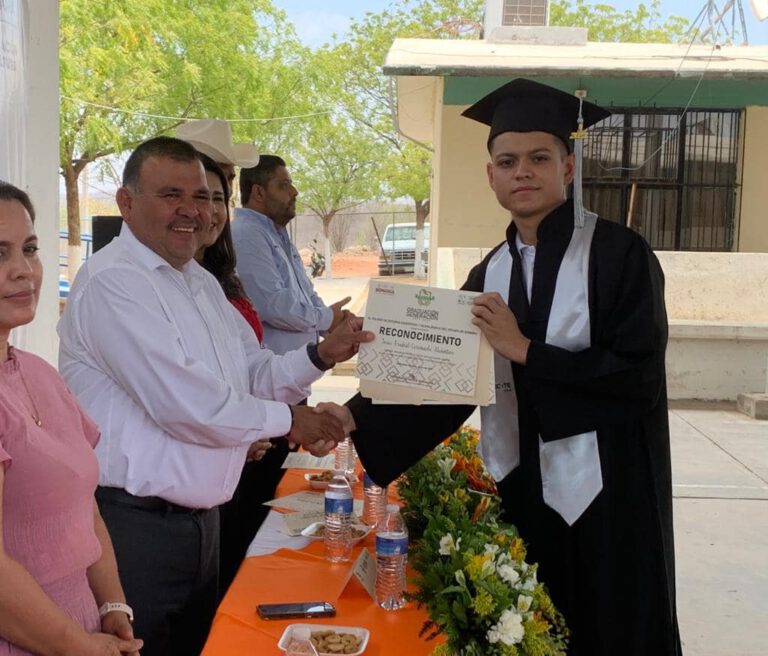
[{"xmin": 398, "ymin": 428, "xmax": 567, "ymax": 656}]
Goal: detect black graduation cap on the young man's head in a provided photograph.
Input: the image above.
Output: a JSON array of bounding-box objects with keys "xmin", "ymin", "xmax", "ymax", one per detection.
[{"xmin": 462, "ymin": 78, "xmax": 611, "ymax": 152}]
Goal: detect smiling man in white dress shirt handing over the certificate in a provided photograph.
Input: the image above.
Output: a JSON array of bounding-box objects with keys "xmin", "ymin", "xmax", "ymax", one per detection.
[{"xmin": 59, "ymin": 137, "xmax": 369, "ymax": 656}]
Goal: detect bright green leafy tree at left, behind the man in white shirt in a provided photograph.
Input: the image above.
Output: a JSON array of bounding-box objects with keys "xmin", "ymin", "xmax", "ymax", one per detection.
[{"xmin": 60, "ymin": 0, "xmax": 308, "ymax": 274}]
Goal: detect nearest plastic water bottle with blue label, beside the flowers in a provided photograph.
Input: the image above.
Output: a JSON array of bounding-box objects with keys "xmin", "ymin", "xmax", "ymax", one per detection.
[{"xmin": 376, "ymin": 504, "xmax": 408, "ymax": 610}]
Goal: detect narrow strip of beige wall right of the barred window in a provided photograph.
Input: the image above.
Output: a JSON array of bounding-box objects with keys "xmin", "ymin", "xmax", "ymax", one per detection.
[{"xmin": 737, "ymin": 107, "xmax": 768, "ymax": 253}]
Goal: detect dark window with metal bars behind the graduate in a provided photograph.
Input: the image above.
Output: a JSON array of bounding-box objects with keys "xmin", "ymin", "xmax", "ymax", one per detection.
[{"xmin": 583, "ymin": 109, "xmax": 741, "ymax": 251}]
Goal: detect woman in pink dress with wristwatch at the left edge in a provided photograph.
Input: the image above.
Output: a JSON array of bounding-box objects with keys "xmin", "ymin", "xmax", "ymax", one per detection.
[{"xmin": 0, "ymin": 181, "xmax": 142, "ymax": 656}]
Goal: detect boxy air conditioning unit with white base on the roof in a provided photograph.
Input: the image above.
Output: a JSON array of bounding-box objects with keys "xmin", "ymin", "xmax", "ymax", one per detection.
[{"xmin": 483, "ymin": 0, "xmax": 587, "ymax": 45}]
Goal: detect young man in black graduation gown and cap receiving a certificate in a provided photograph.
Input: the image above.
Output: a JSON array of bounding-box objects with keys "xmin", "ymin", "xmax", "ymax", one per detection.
[{"xmin": 318, "ymin": 80, "xmax": 682, "ymax": 656}]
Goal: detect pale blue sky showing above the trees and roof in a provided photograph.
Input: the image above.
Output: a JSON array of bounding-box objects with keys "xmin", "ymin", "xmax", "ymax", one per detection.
[{"xmin": 273, "ymin": 0, "xmax": 768, "ymax": 47}]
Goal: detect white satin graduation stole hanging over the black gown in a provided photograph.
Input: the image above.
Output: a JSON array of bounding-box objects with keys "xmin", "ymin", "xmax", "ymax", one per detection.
[{"xmin": 479, "ymin": 212, "xmax": 603, "ymax": 526}]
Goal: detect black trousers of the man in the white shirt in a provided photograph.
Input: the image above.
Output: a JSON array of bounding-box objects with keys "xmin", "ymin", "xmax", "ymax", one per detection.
[{"xmin": 96, "ymin": 488, "xmax": 219, "ymax": 656}]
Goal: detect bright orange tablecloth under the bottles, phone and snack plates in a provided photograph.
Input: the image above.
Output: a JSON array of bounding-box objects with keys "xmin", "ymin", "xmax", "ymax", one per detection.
[{"xmin": 203, "ymin": 470, "xmax": 437, "ymax": 656}]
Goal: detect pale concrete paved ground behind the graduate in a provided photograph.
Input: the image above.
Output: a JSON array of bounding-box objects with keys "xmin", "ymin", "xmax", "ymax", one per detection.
[{"xmin": 310, "ymin": 375, "xmax": 768, "ymax": 656}]
